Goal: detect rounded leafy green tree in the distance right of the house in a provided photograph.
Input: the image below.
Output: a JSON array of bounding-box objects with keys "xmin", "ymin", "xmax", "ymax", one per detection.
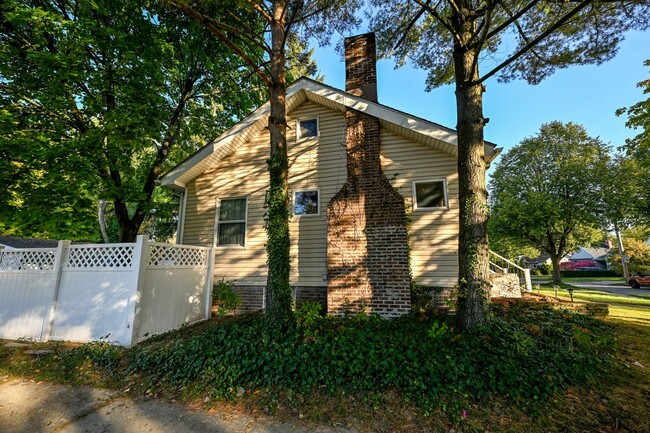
[{"xmin": 490, "ymin": 122, "xmax": 608, "ymax": 282}]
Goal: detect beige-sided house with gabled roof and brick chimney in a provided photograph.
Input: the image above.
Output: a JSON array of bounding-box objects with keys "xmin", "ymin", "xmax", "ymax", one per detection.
[{"xmin": 161, "ymin": 34, "xmax": 500, "ymax": 317}]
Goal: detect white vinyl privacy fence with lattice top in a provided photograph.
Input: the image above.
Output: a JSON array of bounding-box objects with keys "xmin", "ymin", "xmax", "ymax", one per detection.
[{"xmin": 0, "ymin": 236, "xmax": 214, "ymax": 346}]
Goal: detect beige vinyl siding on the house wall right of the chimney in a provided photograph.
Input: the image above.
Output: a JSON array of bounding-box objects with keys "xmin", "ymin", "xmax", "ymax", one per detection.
[{"xmin": 381, "ymin": 130, "xmax": 458, "ymax": 287}]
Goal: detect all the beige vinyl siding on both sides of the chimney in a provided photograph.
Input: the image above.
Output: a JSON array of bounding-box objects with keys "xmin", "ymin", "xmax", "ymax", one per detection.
[{"xmin": 183, "ymin": 98, "xmax": 458, "ymax": 287}]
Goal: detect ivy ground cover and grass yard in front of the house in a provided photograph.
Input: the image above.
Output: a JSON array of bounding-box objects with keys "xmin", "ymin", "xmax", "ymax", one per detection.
[{"xmin": 0, "ymin": 294, "xmax": 650, "ymax": 433}]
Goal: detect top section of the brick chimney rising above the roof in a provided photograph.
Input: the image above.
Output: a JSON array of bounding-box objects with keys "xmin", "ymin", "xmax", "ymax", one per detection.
[{"xmin": 344, "ymin": 33, "xmax": 377, "ymax": 102}]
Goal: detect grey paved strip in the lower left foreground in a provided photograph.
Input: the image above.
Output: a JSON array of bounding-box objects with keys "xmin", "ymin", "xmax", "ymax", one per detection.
[{"xmin": 0, "ymin": 378, "xmax": 349, "ymax": 433}]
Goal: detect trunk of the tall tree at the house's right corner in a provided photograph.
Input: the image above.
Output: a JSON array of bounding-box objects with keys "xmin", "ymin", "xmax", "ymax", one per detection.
[{"xmin": 452, "ymin": 9, "xmax": 490, "ymax": 330}]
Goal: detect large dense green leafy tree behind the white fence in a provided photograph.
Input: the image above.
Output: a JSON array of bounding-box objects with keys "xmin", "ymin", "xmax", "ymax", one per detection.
[{"xmin": 0, "ymin": 0, "xmax": 261, "ymax": 242}]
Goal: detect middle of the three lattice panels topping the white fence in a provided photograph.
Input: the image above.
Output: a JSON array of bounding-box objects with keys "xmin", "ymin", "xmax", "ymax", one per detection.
[{"xmin": 65, "ymin": 245, "xmax": 135, "ymax": 268}]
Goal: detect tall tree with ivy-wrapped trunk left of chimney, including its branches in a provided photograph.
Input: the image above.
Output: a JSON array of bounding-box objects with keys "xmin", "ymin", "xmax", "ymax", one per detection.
[{"xmin": 171, "ymin": 0, "xmax": 360, "ymax": 329}]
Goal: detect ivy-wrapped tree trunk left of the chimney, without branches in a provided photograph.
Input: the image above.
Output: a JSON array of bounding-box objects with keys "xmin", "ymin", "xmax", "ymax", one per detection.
[{"xmin": 265, "ymin": 1, "xmax": 293, "ymax": 330}]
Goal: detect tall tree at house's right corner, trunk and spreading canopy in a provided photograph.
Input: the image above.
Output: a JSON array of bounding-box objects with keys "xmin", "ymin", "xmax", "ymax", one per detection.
[{"xmin": 372, "ymin": 0, "xmax": 650, "ymax": 329}]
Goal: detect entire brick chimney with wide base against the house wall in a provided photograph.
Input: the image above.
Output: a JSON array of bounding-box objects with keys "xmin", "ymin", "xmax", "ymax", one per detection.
[{"xmin": 327, "ymin": 33, "xmax": 411, "ymax": 317}]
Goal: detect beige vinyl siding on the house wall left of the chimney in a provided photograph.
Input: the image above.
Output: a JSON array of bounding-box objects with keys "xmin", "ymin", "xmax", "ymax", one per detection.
[{"xmin": 183, "ymin": 103, "xmax": 346, "ymax": 286}]
